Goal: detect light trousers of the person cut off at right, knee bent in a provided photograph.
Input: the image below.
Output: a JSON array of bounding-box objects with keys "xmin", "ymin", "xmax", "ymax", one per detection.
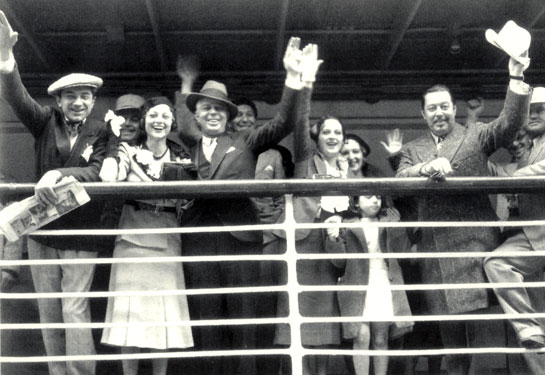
[{"xmin": 484, "ymin": 231, "xmax": 545, "ymax": 341}]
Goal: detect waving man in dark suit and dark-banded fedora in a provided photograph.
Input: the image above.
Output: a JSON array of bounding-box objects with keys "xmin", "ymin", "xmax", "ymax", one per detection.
[{"xmin": 177, "ymin": 38, "xmax": 317, "ymax": 374}]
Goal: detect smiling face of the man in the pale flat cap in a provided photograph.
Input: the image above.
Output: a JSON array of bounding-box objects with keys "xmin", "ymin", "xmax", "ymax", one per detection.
[{"xmin": 56, "ymin": 86, "xmax": 95, "ymax": 122}]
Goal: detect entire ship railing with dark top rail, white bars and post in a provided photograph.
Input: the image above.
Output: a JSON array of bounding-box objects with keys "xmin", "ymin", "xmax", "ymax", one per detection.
[{"xmin": 0, "ymin": 177, "xmax": 545, "ymax": 374}]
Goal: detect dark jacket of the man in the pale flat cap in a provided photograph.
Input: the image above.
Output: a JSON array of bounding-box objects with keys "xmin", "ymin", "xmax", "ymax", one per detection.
[{"xmin": 0, "ymin": 66, "xmax": 108, "ymax": 251}]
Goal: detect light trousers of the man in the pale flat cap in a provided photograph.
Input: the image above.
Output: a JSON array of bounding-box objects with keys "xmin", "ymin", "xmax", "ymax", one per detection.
[{"xmin": 28, "ymin": 238, "xmax": 97, "ymax": 375}]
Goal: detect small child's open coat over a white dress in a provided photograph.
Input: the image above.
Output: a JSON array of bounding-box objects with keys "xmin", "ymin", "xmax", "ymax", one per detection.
[{"xmin": 325, "ymin": 215, "xmax": 414, "ymax": 339}]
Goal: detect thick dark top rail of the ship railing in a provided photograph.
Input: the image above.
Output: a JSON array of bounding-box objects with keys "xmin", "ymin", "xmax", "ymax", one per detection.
[{"xmin": 0, "ymin": 176, "xmax": 545, "ymax": 199}]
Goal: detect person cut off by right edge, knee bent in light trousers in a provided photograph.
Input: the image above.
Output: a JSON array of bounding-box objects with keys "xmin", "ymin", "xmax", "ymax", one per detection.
[{"xmin": 484, "ymin": 87, "xmax": 545, "ymax": 349}]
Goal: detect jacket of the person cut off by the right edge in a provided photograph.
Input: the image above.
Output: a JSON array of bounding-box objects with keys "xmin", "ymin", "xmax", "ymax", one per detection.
[{"xmin": 514, "ymin": 135, "xmax": 545, "ymax": 250}]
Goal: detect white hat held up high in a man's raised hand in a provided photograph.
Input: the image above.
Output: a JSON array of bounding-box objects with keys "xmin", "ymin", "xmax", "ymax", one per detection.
[{"xmin": 485, "ymin": 21, "xmax": 532, "ymax": 64}]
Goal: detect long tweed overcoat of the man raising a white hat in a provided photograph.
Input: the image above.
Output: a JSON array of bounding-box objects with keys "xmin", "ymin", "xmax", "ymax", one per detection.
[{"xmin": 396, "ymin": 91, "xmax": 529, "ymax": 314}]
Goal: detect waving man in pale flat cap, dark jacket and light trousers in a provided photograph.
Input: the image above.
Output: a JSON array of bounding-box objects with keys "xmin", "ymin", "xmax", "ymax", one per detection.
[{"xmin": 0, "ymin": 11, "xmax": 108, "ymax": 375}]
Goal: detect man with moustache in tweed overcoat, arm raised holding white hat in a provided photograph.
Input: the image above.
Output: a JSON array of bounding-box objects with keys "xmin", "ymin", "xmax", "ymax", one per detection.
[{"xmin": 396, "ymin": 24, "xmax": 530, "ymax": 374}]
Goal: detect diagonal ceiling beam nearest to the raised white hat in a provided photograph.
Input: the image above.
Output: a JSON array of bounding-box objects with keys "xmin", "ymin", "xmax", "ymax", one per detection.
[{"xmin": 381, "ymin": 0, "xmax": 422, "ymax": 70}]
